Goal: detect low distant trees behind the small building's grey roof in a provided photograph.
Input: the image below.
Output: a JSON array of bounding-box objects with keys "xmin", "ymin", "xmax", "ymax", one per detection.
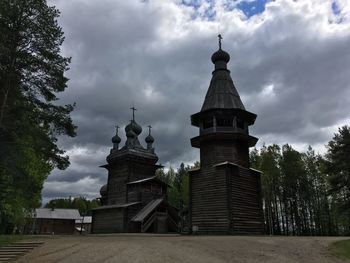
[{"xmin": 45, "ymin": 197, "xmax": 101, "ymax": 216}]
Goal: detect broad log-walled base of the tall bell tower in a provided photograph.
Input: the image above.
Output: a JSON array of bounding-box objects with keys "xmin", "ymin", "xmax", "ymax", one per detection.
[{"xmin": 190, "ymin": 164, "xmax": 263, "ymax": 234}]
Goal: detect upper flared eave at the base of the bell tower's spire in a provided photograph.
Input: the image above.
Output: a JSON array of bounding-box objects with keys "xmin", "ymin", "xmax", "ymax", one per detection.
[{"xmin": 191, "ymin": 108, "xmax": 257, "ymax": 127}]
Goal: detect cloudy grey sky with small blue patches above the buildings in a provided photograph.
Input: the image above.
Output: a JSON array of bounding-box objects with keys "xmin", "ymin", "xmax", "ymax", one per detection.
[{"xmin": 43, "ymin": 0, "xmax": 350, "ymax": 202}]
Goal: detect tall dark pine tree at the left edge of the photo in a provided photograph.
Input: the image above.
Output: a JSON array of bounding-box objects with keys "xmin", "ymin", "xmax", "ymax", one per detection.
[{"xmin": 0, "ymin": 0, "xmax": 75, "ymax": 233}]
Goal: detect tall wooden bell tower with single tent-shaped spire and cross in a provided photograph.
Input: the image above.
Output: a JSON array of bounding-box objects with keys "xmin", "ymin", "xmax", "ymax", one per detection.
[{"xmin": 189, "ymin": 35, "xmax": 263, "ymax": 234}]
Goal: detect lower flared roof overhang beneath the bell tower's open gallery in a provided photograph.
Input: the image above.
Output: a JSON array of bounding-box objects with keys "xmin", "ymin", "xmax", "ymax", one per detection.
[{"xmin": 191, "ymin": 132, "xmax": 258, "ymax": 148}]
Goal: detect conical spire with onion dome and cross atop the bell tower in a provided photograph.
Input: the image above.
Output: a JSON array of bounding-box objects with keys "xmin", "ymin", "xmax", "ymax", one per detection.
[{"xmin": 201, "ymin": 35, "xmax": 245, "ymax": 111}]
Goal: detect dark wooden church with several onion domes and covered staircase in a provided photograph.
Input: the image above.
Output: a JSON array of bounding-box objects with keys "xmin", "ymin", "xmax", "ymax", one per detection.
[{"xmin": 91, "ymin": 112, "xmax": 178, "ymax": 233}]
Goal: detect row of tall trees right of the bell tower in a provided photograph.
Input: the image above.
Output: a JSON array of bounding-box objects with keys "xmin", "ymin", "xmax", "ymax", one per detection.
[{"xmin": 250, "ymin": 126, "xmax": 350, "ymax": 235}]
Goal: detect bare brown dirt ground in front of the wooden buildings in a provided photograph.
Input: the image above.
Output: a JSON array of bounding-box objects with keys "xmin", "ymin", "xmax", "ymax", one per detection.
[{"xmin": 16, "ymin": 234, "xmax": 349, "ymax": 263}]
